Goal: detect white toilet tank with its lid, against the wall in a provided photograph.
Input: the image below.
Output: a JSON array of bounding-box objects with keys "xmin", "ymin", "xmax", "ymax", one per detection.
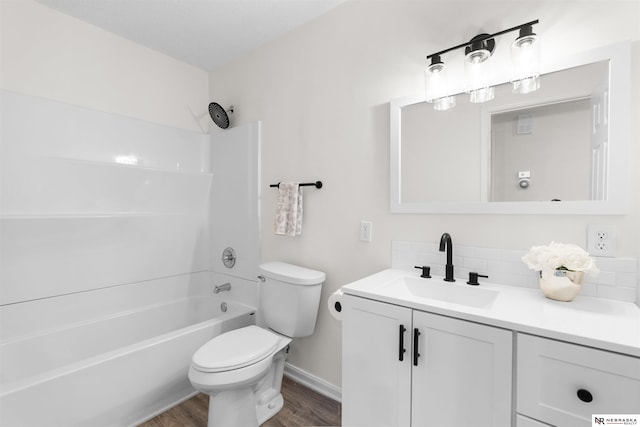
[{"xmin": 259, "ymin": 262, "xmax": 325, "ymax": 338}]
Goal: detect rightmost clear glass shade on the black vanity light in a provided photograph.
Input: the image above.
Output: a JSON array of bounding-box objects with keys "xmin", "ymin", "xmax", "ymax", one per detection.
[{"xmin": 511, "ymin": 34, "xmax": 540, "ymax": 93}]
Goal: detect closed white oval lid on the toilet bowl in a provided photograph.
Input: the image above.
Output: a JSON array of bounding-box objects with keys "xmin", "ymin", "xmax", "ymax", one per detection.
[{"xmin": 192, "ymin": 325, "xmax": 279, "ymax": 372}]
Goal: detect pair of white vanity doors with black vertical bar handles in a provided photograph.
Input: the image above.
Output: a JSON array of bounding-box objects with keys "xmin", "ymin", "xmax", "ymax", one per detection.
[{"xmin": 342, "ymin": 295, "xmax": 513, "ymax": 427}]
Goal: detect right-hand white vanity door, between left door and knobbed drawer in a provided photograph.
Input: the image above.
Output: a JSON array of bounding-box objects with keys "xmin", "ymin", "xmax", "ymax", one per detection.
[{"xmin": 412, "ymin": 311, "xmax": 513, "ymax": 427}]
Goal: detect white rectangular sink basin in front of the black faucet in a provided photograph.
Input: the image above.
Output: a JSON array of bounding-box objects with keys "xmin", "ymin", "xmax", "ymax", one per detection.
[{"xmin": 380, "ymin": 277, "xmax": 498, "ymax": 309}]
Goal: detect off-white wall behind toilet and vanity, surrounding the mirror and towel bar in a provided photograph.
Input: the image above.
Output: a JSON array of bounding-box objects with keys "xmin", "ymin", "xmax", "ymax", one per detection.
[{"xmin": 211, "ymin": 0, "xmax": 640, "ymax": 385}]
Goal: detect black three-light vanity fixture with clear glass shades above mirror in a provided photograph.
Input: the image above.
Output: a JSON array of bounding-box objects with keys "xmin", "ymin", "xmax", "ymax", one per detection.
[{"xmin": 425, "ymin": 20, "xmax": 540, "ymax": 110}]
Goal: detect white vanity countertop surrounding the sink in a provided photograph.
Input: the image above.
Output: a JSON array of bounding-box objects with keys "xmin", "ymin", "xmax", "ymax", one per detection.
[{"xmin": 342, "ymin": 269, "xmax": 640, "ymax": 357}]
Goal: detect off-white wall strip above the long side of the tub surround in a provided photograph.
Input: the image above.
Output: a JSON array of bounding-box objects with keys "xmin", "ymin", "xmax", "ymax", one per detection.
[{"xmin": 0, "ymin": 0, "xmax": 209, "ymax": 132}]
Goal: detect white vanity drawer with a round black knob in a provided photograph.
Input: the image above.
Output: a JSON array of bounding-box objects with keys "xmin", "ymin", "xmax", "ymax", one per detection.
[{"xmin": 517, "ymin": 334, "xmax": 640, "ymax": 427}]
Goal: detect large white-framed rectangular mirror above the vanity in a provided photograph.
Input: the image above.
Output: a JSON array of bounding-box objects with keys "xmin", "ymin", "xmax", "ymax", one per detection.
[{"xmin": 390, "ymin": 43, "xmax": 631, "ymax": 214}]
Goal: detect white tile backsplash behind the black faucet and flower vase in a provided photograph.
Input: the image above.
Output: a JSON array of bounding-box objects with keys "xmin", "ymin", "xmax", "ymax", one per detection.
[{"xmin": 391, "ymin": 241, "xmax": 638, "ymax": 302}]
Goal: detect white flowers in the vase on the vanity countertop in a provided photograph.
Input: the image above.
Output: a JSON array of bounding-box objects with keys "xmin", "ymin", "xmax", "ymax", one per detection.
[{"xmin": 522, "ymin": 242, "xmax": 600, "ymax": 275}]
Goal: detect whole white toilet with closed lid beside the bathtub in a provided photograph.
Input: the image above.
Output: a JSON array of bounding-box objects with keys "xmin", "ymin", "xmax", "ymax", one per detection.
[{"xmin": 189, "ymin": 262, "xmax": 325, "ymax": 427}]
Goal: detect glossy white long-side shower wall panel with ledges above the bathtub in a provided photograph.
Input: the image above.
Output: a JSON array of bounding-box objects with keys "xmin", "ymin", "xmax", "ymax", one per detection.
[{"xmin": 0, "ymin": 91, "xmax": 211, "ymax": 305}]
